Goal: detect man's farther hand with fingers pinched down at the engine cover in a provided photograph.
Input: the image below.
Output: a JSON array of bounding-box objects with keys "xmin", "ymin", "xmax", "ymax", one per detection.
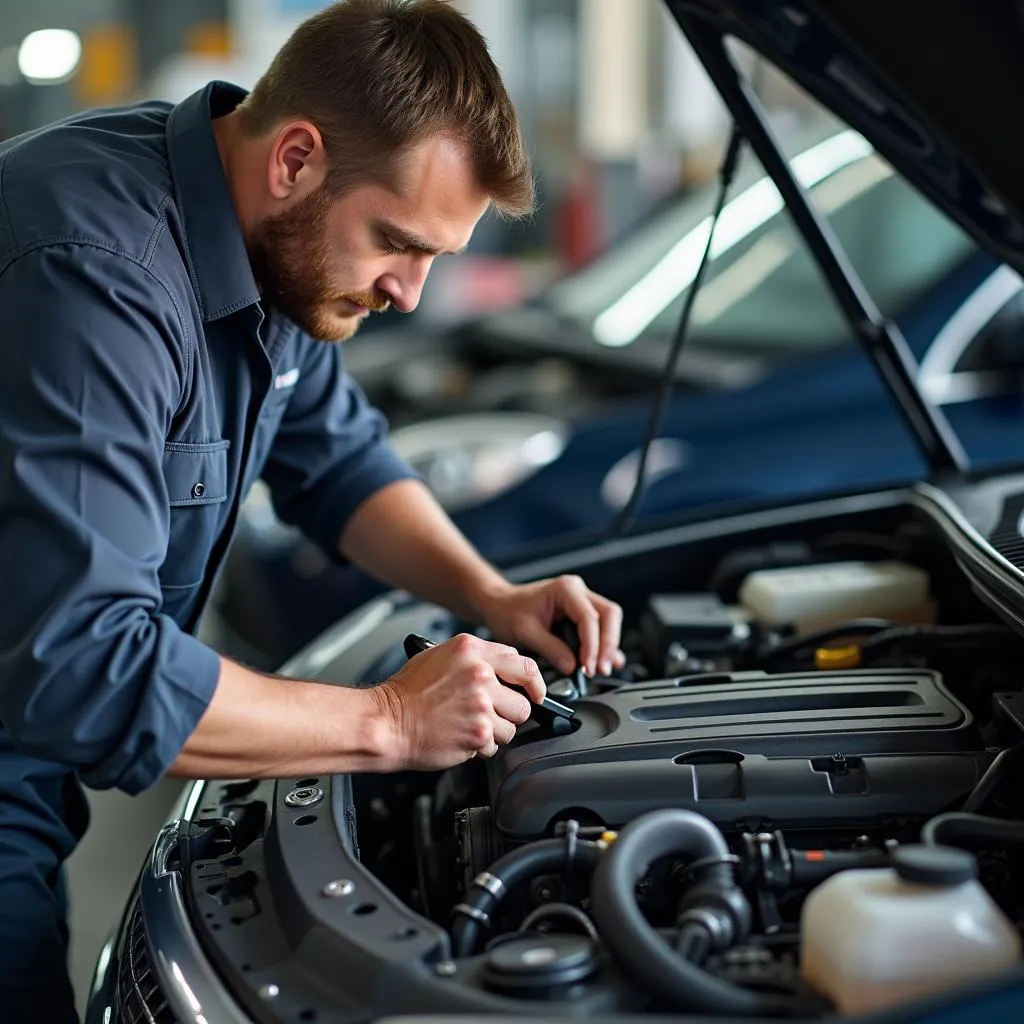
[{"xmin": 476, "ymin": 575, "xmax": 626, "ymax": 676}]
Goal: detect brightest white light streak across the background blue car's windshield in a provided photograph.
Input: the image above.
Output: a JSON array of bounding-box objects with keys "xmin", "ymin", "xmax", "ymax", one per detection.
[{"xmin": 594, "ymin": 130, "xmax": 874, "ymax": 348}]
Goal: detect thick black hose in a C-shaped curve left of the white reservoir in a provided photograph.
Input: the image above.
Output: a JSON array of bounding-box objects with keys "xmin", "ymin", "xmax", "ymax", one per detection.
[{"xmin": 591, "ymin": 810, "xmax": 794, "ymax": 1016}]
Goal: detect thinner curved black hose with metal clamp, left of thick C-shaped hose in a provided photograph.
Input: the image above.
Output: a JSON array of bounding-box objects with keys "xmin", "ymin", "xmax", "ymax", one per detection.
[{"xmin": 452, "ymin": 839, "xmax": 598, "ymax": 956}]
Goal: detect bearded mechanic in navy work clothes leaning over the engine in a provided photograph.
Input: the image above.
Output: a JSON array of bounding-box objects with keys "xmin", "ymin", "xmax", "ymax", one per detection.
[{"xmin": 0, "ymin": 0, "xmax": 624, "ymax": 1024}]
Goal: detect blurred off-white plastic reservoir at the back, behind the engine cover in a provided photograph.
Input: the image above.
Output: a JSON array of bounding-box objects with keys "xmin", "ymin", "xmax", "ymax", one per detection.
[{"xmin": 739, "ymin": 561, "xmax": 932, "ymax": 634}]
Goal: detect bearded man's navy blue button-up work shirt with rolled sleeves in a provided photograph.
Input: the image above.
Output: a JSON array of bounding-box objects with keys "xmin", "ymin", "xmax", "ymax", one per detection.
[{"xmin": 0, "ymin": 83, "xmax": 413, "ymax": 802}]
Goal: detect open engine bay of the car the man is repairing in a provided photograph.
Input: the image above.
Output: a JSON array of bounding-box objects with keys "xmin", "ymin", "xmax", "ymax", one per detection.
[{"xmin": 184, "ymin": 491, "xmax": 1024, "ymax": 1020}]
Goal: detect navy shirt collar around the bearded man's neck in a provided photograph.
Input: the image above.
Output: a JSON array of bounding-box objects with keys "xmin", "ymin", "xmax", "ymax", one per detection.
[{"xmin": 167, "ymin": 82, "xmax": 259, "ymax": 321}]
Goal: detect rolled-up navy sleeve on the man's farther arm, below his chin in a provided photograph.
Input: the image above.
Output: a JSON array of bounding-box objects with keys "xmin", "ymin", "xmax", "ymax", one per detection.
[{"xmin": 263, "ymin": 339, "xmax": 419, "ymax": 560}]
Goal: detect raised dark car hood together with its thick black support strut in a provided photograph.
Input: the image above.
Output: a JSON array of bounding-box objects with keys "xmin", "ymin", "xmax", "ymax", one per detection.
[{"xmin": 666, "ymin": 0, "xmax": 1024, "ymax": 476}]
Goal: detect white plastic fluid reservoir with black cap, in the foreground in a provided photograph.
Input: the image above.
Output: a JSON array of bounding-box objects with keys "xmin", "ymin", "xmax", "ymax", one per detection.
[{"xmin": 800, "ymin": 846, "xmax": 1021, "ymax": 1014}]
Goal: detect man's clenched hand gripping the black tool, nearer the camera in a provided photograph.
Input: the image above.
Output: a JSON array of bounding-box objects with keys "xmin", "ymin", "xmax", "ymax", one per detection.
[{"xmin": 369, "ymin": 634, "xmax": 545, "ymax": 771}]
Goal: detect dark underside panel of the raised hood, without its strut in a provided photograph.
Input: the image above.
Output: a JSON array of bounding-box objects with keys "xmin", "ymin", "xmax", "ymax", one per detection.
[{"xmin": 667, "ymin": 0, "xmax": 1024, "ymax": 271}]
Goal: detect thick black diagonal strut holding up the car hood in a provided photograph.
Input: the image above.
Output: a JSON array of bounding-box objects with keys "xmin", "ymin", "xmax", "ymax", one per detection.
[{"xmin": 674, "ymin": 8, "xmax": 970, "ymax": 476}]
